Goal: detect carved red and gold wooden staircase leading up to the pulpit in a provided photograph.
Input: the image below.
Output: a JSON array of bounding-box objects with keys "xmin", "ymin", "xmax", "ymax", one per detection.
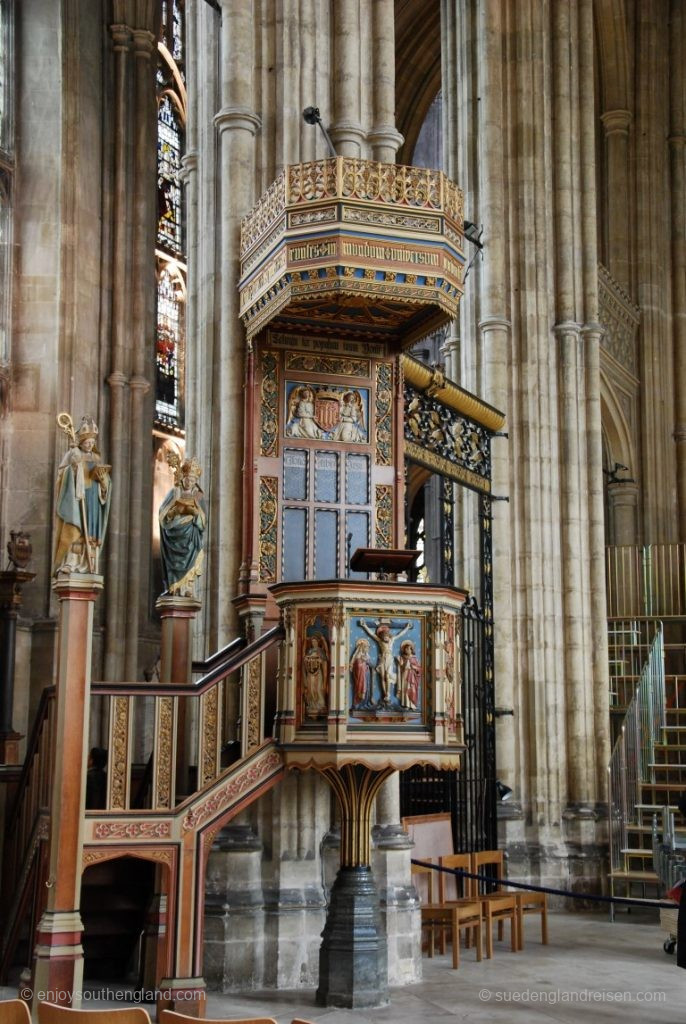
[{"xmin": 0, "ymin": 627, "xmax": 285, "ymax": 987}]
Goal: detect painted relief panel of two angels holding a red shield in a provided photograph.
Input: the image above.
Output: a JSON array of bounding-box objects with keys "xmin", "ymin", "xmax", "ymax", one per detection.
[{"xmin": 286, "ymin": 381, "xmax": 370, "ymax": 444}]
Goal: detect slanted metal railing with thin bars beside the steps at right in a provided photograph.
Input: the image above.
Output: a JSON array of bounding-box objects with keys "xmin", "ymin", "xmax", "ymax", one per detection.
[{"xmin": 608, "ymin": 623, "xmax": 667, "ymax": 871}]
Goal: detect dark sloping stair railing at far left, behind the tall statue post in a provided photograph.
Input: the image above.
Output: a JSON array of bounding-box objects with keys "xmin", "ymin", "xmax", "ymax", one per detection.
[{"xmin": 0, "ymin": 686, "xmax": 56, "ymax": 977}]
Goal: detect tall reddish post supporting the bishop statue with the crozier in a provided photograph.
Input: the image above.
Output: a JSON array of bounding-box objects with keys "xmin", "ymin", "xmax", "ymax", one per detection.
[{"xmin": 34, "ymin": 573, "xmax": 102, "ymax": 1008}]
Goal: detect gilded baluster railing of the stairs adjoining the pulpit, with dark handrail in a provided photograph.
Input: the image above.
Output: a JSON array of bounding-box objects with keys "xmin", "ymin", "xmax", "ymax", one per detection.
[{"xmin": 91, "ymin": 627, "xmax": 284, "ymax": 811}]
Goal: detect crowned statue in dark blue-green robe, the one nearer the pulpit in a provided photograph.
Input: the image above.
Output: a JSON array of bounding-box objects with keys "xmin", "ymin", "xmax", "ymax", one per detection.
[{"xmin": 160, "ymin": 453, "xmax": 207, "ymax": 598}]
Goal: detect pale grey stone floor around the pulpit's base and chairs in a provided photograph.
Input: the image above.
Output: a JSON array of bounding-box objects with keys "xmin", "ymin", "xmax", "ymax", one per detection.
[{"xmin": 0, "ymin": 913, "xmax": 686, "ymax": 1024}]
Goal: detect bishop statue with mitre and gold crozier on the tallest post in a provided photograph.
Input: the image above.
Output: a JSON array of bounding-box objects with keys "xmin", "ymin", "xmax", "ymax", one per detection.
[{"xmin": 52, "ymin": 413, "xmax": 112, "ymax": 575}]
